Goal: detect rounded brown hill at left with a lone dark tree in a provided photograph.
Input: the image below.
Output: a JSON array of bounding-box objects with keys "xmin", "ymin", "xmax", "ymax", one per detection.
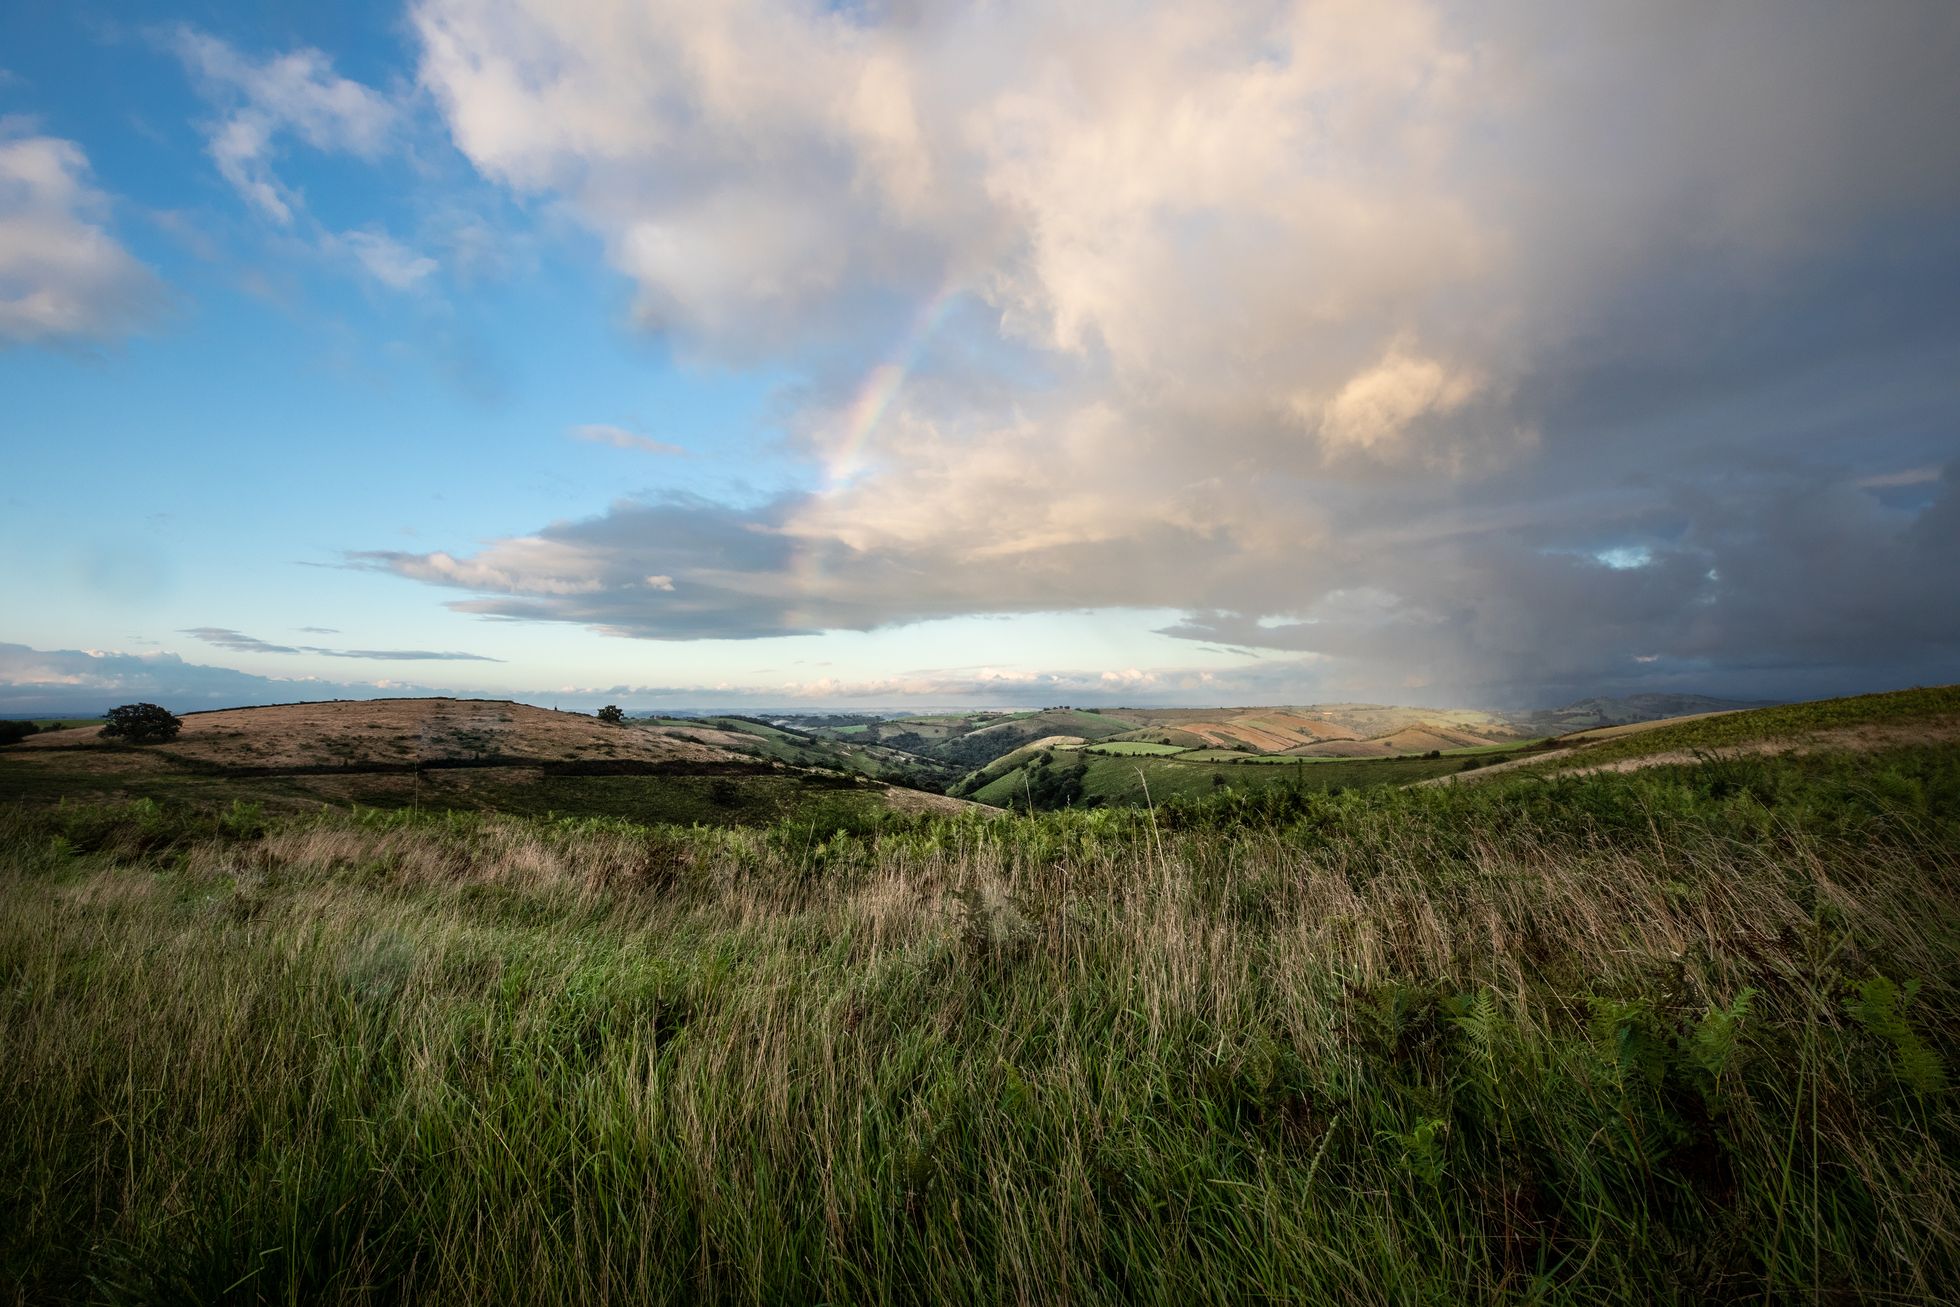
[{"xmin": 0, "ymin": 698, "xmax": 980, "ymax": 825}]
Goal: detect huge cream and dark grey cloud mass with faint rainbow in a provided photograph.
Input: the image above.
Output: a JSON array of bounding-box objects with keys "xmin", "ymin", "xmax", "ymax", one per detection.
[{"xmin": 382, "ymin": 0, "xmax": 1960, "ymax": 705}]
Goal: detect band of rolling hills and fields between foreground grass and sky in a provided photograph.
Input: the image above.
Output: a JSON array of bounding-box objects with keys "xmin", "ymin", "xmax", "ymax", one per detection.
[{"xmin": 0, "ymin": 696, "xmax": 1779, "ymax": 823}]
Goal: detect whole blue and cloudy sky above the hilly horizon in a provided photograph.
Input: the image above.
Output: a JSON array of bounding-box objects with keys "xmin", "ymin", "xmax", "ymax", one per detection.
[{"xmin": 0, "ymin": 0, "xmax": 1960, "ymax": 713}]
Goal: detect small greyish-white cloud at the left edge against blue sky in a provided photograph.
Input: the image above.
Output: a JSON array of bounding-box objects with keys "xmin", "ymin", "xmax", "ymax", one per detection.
[{"xmin": 0, "ymin": 120, "xmax": 161, "ymax": 345}]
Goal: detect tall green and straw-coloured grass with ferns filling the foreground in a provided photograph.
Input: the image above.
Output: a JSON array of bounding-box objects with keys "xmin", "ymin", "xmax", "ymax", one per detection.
[{"xmin": 0, "ymin": 750, "xmax": 1960, "ymax": 1303}]
